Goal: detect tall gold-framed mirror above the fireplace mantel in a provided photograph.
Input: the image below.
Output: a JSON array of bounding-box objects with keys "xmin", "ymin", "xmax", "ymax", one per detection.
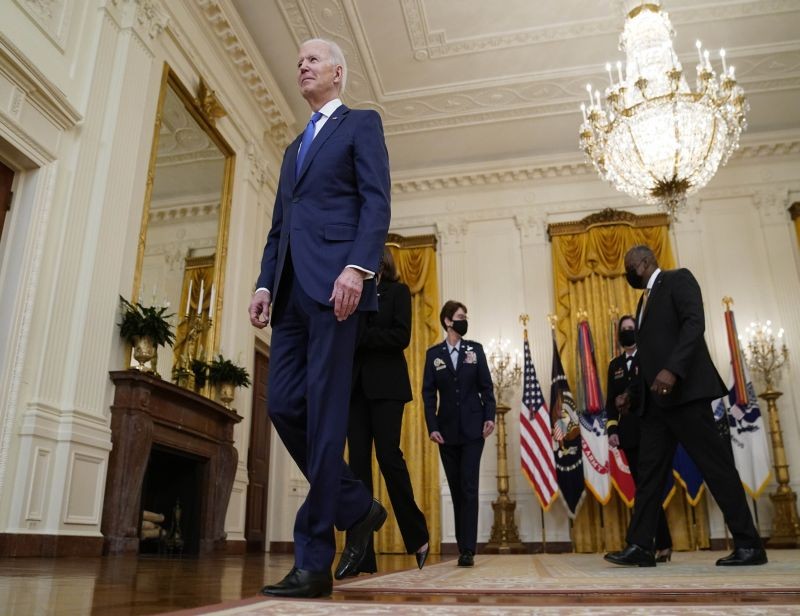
[{"xmin": 133, "ymin": 65, "xmax": 234, "ymax": 389}]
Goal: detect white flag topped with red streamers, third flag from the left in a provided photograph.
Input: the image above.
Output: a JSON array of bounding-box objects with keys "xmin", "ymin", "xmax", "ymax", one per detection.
[{"xmin": 576, "ymin": 321, "xmax": 611, "ymax": 505}]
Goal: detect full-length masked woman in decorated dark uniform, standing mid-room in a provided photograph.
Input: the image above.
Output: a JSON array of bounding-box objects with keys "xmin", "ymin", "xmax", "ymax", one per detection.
[{"xmin": 422, "ymin": 300, "xmax": 495, "ymax": 567}]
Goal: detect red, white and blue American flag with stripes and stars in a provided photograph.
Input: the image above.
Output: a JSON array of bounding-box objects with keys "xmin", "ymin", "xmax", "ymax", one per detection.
[{"xmin": 519, "ymin": 330, "xmax": 558, "ymax": 511}]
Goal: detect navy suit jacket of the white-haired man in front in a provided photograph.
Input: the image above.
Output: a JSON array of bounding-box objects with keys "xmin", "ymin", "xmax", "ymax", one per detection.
[{"xmin": 256, "ymin": 105, "xmax": 391, "ymax": 310}]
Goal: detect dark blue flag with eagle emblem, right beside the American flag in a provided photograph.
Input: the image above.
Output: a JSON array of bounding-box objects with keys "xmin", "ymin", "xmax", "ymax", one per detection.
[{"xmin": 550, "ymin": 333, "xmax": 584, "ymax": 518}]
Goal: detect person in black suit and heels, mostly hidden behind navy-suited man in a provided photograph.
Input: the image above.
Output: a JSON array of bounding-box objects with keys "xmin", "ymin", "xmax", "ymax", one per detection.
[{"xmin": 347, "ymin": 248, "xmax": 428, "ymax": 573}]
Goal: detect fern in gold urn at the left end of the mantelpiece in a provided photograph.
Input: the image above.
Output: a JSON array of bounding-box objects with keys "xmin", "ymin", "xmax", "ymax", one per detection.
[{"xmin": 119, "ymin": 295, "xmax": 175, "ymax": 372}]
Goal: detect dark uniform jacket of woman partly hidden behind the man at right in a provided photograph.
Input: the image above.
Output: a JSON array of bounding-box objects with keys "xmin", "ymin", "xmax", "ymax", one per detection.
[{"xmin": 606, "ymin": 353, "xmax": 641, "ymax": 449}]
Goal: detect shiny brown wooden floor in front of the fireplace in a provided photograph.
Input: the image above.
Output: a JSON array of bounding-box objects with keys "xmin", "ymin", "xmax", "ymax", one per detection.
[{"xmin": 0, "ymin": 554, "xmax": 444, "ymax": 616}]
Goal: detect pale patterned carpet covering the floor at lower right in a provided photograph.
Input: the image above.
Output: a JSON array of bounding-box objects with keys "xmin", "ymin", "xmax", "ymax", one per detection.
[{"xmin": 172, "ymin": 550, "xmax": 800, "ymax": 616}]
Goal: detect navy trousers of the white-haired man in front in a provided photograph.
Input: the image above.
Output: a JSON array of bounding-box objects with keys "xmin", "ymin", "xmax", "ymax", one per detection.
[{"xmin": 269, "ymin": 272, "xmax": 372, "ymax": 572}]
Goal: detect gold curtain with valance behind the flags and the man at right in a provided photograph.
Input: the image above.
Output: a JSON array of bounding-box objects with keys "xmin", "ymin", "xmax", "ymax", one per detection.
[{"xmin": 548, "ymin": 210, "xmax": 709, "ymax": 552}]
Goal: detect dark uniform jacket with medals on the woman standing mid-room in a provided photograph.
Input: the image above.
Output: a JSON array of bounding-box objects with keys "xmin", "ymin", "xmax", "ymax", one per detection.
[{"xmin": 422, "ymin": 338, "xmax": 496, "ymax": 445}]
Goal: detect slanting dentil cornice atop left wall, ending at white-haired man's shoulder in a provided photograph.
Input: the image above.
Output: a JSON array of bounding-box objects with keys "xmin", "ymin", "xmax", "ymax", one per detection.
[{"xmin": 195, "ymin": 0, "xmax": 294, "ymax": 149}]
